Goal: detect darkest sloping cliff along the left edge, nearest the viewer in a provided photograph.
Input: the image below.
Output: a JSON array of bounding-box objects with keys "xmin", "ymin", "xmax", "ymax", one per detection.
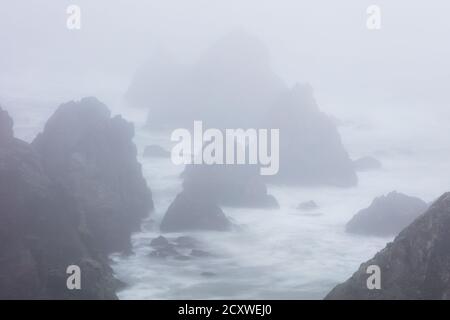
[{"xmin": 0, "ymin": 108, "xmax": 118, "ymax": 299}]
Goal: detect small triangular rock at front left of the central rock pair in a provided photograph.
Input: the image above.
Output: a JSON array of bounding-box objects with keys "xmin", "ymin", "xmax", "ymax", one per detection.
[{"xmin": 160, "ymin": 191, "xmax": 231, "ymax": 232}]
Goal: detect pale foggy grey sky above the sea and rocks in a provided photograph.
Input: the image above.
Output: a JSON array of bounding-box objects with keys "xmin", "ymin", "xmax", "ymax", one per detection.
[{"xmin": 0, "ymin": 0, "xmax": 450, "ymax": 117}]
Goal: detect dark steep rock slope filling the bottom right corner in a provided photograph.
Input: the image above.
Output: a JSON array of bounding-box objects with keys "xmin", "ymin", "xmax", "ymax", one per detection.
[{"xmin": 326, "ymin": 193, "xmax": 450, "ymax": 300}]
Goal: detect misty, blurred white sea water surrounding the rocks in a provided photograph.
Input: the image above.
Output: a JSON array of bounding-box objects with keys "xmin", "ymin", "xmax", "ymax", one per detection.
[{"xmin": 2, "ymin": 97, "xmax": 450, "ymax": 299}]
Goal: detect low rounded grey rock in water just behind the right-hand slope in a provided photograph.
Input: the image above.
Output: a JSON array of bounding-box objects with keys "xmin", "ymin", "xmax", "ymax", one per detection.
[{"xmin": 346, "ymin": 191, "xmax": 428, "ymax": 236}]
